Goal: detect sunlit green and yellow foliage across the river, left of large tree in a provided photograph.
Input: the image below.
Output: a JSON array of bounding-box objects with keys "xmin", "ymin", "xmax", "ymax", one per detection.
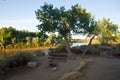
[{"xmin": 0, "ymin": 27, "xmax": 53, "ymax": 50}]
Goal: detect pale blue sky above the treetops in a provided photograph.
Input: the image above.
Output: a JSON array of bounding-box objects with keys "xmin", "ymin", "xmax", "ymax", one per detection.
[{"xmin": 0, "ymin": 0, "xmax": 120, "ymax": 31}]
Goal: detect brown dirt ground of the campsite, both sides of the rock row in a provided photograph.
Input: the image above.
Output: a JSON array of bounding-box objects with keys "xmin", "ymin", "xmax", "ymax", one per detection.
[{"xmin": 6, "ymin": 56, "xmax": 120, "ymax": 80}]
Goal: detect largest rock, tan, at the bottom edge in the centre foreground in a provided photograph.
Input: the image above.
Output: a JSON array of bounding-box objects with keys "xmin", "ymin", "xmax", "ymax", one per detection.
[{"xmin": 60, "ymin": 71, "xmax": 81, "ymax": 80}]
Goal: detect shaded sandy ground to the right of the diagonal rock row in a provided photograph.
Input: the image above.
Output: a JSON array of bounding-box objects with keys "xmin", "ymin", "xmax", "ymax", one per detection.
[{"xmin": 77, "ymin": 57, "xmax": 120, "ymax": 80}]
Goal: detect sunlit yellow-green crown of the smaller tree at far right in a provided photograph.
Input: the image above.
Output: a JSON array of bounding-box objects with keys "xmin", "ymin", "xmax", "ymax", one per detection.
[{"xmin": 98, "ymin": 18, "xmax": 118, "ymax": 44}]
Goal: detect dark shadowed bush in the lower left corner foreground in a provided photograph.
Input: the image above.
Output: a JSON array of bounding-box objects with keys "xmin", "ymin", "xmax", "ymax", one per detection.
[{"xmin": 0, "ymin": 52, "xmax": 35, "ymax": 77}]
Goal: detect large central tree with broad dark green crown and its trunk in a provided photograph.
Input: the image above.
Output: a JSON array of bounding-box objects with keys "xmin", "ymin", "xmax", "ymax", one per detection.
[{"xmin": 35, "ymin": 3, "xmax": 96, "ymax": 55}]
